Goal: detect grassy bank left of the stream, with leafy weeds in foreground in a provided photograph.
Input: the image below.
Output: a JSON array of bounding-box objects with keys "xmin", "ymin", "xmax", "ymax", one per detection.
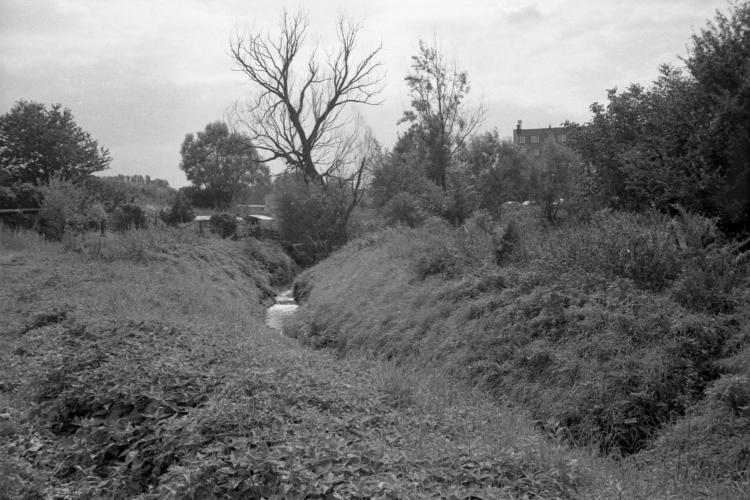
[{"xmin": 0, "ymin": 231, "xmax": 600, "ymax": 498}]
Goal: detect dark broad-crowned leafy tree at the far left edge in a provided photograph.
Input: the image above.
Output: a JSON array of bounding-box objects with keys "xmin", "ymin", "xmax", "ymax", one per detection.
[{"xmin": 0, "ymin": 101, "xmax": 111, "ymax": 185}]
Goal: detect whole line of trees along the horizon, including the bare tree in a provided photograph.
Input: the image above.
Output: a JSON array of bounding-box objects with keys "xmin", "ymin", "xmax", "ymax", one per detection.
[{"xmin": 0, "ymin": 2, "xmax": 750, "ymax": 260}]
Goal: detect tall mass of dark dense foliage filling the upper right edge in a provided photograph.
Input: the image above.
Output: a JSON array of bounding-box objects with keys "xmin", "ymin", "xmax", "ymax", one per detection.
[{"xmin": 571, "ymin": 3, "xmax": 750, "ymax": 232}]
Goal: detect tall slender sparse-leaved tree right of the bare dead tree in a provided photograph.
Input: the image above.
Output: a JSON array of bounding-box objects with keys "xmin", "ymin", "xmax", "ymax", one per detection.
[{"xmin": 401, "ymin": 40, "xmax": 483, "ymax": 190}]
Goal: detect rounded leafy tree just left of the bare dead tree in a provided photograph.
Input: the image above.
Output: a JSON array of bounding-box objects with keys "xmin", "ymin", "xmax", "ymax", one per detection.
[{"xmin": 180, "ymin": 122, "xmax": 269, "ymax": 207}]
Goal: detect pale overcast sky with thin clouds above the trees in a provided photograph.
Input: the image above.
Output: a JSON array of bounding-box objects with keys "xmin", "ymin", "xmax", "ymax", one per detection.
[{"xmin": 0, "ymin": 0, "xmax": 728, "ymax": 186}]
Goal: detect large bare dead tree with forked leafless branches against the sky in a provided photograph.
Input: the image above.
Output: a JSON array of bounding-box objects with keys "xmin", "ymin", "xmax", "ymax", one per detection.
[{"xmin": 230, "ymin": 11, "xmax": 383, "ymax": 184}]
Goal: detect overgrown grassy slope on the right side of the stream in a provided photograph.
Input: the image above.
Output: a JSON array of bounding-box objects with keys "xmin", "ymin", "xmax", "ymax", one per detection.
[{"xmin": 291, "ymin": 209, "xmax": 750, "ymax": 498}]
